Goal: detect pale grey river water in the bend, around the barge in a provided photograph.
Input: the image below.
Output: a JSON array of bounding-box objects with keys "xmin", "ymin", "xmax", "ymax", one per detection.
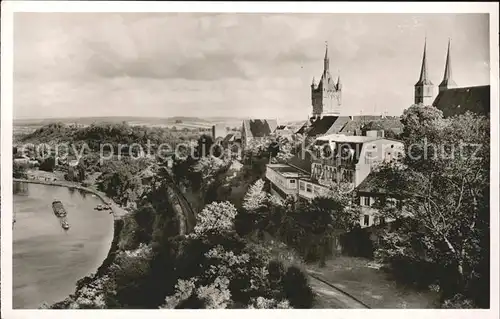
[{"xmin": 12, "ymin": 183, "xmax": 113, "ymax": 309}]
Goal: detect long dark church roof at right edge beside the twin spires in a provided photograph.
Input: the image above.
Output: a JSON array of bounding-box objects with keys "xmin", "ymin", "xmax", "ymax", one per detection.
[{"xmin": 432, "ymin": 85, "xmax": 490, "ymax": 117}]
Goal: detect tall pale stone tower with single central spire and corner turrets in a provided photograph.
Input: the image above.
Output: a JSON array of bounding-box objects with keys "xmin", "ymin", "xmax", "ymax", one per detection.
[{"xmin": 311, "ymin": 43, "xmax": 342, "ymax": 117}]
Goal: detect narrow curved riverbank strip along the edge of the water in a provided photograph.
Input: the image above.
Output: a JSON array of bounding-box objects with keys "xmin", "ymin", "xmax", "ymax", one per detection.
[{"xmin": 13, "ymin": 178, "xmax": 130, "ymax": 304}]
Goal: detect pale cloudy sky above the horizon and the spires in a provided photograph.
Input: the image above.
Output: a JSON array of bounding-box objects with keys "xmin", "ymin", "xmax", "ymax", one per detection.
[{"xmin": 13, "ymin": 13, "xmax": 490, "ymax": 120}]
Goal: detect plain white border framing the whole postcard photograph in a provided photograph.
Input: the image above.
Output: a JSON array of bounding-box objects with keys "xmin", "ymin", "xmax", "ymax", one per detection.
[{"xmin": 0, "ymin": 1, "xmax": 500, "ymax": 319}]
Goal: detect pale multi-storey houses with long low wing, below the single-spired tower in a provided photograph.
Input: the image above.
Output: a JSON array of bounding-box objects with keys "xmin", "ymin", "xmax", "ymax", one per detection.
[{"xmin": 266, "ymin": 134, "xmax": 404, "ymax": 228}]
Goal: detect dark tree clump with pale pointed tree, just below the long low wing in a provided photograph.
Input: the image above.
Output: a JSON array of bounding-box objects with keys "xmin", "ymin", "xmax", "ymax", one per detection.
[{"xmin": 240, "ymin": 180, "xmax": 359, "ymax": 261}]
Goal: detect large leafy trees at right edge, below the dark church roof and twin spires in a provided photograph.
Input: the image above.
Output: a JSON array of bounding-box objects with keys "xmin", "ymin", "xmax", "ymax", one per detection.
[{"xmin": 376, "ymin": 106, "xmax": 490, "ymax": 305}]
